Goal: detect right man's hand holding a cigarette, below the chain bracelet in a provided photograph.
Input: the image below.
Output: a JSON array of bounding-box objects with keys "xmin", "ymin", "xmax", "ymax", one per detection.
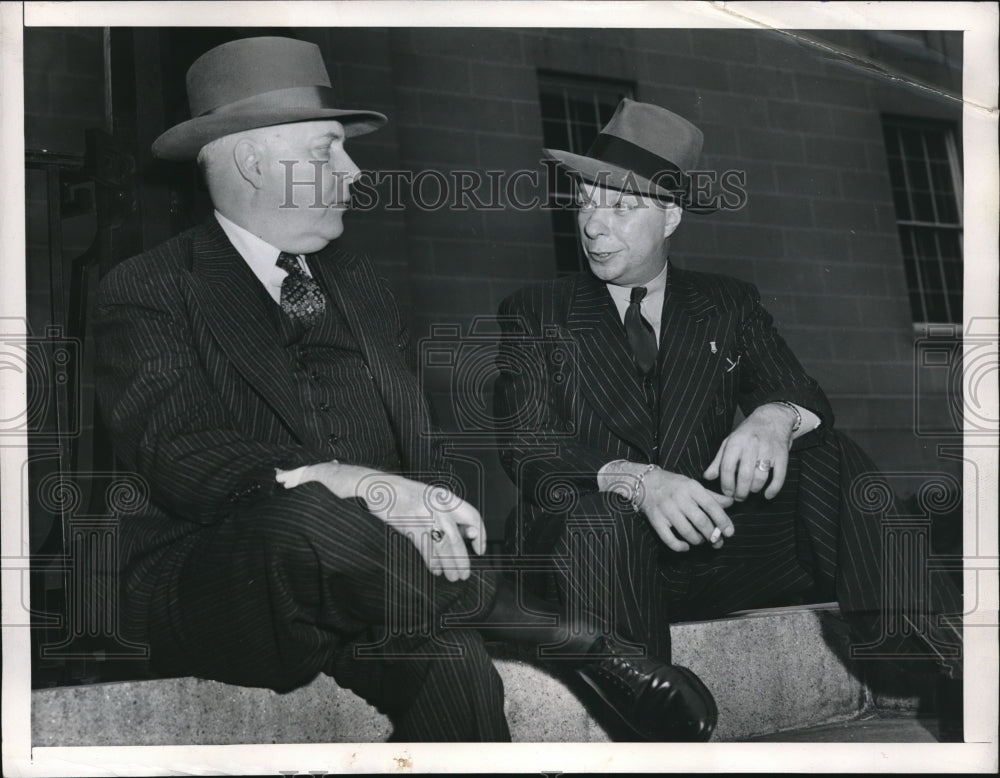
[{"xmin": 637, "ymin": 468, "xmax": 733, "ymax": 551}]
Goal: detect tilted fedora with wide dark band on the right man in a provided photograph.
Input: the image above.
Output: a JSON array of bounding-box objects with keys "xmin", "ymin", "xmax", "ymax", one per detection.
[{"xmin": 542, "ymin": 98, "xmax": 717, "ymax": 213}]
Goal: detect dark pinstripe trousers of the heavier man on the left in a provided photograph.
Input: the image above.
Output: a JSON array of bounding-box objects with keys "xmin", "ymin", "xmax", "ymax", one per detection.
[{"xmin": 149, "ymin": 483, "xmax": 509, "ymax": 741}]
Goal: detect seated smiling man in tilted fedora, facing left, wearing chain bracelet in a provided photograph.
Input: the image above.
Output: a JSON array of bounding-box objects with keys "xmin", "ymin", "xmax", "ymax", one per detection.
[{"xmin": 495, "ymin": 99, "xmax": 961, "ymax": 728}]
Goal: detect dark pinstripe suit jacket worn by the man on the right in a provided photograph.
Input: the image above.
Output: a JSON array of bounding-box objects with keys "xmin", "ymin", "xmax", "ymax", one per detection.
[{"xmin": 495, "ymin": 265, "xmax": 833, "ymax": 520}]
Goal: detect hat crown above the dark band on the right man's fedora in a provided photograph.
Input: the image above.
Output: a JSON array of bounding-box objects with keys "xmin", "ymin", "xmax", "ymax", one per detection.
[{"xmin": 601, "ymin": 98, "xmax": 704, "ymax": 173}]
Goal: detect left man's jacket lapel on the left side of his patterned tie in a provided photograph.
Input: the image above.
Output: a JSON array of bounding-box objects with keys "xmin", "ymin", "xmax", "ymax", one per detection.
[{"xmin": 192, "ymin": 219, "xmax": 304, "ymax": 439}]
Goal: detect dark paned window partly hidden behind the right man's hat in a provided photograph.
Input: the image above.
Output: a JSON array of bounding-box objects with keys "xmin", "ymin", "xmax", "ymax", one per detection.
[{"xmin": 538, "ymin": 73, "xmax": 633, "ymax": 275}]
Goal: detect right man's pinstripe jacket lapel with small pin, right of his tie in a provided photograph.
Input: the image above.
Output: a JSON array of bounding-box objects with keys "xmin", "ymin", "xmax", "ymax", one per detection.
[{"xmin": 659, "ymin": 265, "xmax": 734, "ymax": 469}]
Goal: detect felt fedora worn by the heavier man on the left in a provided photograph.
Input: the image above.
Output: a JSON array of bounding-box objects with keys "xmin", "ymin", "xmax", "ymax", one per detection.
[{"xmin": 153, "ymin": 37, "xmax": 386, "ymax": 159}]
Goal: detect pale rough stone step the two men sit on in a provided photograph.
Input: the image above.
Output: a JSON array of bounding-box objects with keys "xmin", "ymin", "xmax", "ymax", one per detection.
[{"xmin": 32, "ymin": 605, "xmax": 900, "ymax": 746}]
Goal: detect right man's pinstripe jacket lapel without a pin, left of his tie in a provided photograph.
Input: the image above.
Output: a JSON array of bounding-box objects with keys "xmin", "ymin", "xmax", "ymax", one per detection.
[{"xmin": 566, "ymin": 273, "xmax": 653, "ymax": 454}]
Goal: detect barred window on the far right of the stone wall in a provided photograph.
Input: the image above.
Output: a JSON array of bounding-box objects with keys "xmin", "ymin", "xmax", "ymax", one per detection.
[{"xmin": 882, "ymin": 116, "xmax": 962, "ymax": 324}]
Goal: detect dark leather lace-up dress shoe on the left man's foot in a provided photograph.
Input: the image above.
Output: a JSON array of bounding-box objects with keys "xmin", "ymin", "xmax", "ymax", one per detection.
[{"xmin": 576, "ymin": 638, "xmax": 719, "ymax": 742}]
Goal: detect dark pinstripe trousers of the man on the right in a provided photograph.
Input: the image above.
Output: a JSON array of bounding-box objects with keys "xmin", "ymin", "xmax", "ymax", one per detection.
[{"xmin": 524, "ymin": 424, "xmax": 962, "ymax": 660}]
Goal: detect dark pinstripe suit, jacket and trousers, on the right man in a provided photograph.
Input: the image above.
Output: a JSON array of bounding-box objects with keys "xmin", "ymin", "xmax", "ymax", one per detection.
[{"xmin": 495, "ymin": 266, "xmax": 960, "ymax": 658}]
